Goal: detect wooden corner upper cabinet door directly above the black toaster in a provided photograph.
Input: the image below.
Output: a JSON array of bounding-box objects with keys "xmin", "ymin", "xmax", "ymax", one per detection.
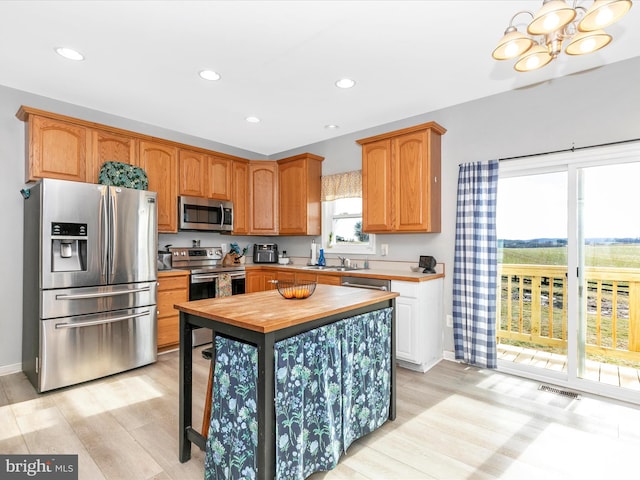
[{"xmin": 249, "ymin": 160, "xmax": 278, "ymax": 235}]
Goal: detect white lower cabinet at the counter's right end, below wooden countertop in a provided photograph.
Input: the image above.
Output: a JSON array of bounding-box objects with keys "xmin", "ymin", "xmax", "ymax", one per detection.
[{"xmin": 391, "ymin": 278, "xmax": 443, "ymax": 372}]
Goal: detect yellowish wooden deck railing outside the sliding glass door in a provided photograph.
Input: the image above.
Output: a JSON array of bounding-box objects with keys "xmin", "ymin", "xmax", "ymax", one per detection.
[{"xmin": 496, "ymin": 264, "xmax": 640, "ymax": 362}]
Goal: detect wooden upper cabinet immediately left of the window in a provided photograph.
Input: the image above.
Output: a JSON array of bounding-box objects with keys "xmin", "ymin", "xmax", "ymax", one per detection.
[{"xmin": 278, "ymin": 153, "xmax": 324, "ymax": 235}]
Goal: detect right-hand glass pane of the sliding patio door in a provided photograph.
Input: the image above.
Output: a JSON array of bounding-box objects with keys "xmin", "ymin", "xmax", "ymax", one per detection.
[{"xmin": 576, "ymin": 163, "xmax": 640, "ymax": 390}]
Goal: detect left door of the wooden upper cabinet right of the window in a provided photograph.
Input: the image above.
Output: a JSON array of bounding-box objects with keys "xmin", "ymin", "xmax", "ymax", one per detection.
[{"xmin": 362, "ymin": 140, "xmax": 393, "ymax": 233}]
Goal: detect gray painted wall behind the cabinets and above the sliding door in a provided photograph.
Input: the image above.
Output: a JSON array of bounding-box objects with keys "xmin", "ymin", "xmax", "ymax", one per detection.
[{"xmin": 0, "ymin": 57, "xmax": 640, "ymax": 374}]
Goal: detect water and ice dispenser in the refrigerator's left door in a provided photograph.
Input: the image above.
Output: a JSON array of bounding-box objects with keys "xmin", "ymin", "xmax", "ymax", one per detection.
[{"xmin": 51, "ymin": 222, "xmax": 87, "ymax": 272}]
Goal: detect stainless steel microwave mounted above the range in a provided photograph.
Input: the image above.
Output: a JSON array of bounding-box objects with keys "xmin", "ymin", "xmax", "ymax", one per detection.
[{"xmin": 178, "ymin": 196, "xmax": 233, "ymax": 232}]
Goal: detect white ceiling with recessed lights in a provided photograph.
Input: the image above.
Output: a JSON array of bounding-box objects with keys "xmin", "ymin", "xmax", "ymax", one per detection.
[{"xmin": 0, "ymin": 0, "xmax": 640, "ymax": 155}]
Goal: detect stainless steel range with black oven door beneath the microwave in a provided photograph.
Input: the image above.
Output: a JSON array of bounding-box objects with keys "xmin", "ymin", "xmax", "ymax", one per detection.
[{"xmin": 169, "ymin": 247, "xmax": 245, "ymax": 346}]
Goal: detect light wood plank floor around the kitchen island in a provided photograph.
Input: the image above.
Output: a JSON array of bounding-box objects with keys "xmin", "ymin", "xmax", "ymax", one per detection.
[{"xmin": 0, "ymin": 352, "xmax": 640, "ymax": 480}]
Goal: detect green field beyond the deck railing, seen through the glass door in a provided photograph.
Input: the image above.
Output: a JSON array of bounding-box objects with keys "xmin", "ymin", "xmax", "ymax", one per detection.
[{"xmin": 498, "ymin": 243, "xmax": 640, "ymax": 268}]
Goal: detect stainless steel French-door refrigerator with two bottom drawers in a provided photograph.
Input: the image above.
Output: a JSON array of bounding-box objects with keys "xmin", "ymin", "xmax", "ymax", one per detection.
[{"xmin": 22, "ymin": 179, "xmax": 158, "ymax": 392}]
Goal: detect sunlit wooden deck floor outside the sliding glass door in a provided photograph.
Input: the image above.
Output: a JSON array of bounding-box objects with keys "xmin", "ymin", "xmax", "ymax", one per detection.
[{"xmin": 498, "ymin": 344, "xmax": 640, "ymax": 391}]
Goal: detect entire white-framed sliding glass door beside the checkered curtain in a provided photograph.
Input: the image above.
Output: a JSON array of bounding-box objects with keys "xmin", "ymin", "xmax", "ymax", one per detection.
[{"xmin": 496, "ymin": 146, "xmax": 640, "ymax": 402}]
